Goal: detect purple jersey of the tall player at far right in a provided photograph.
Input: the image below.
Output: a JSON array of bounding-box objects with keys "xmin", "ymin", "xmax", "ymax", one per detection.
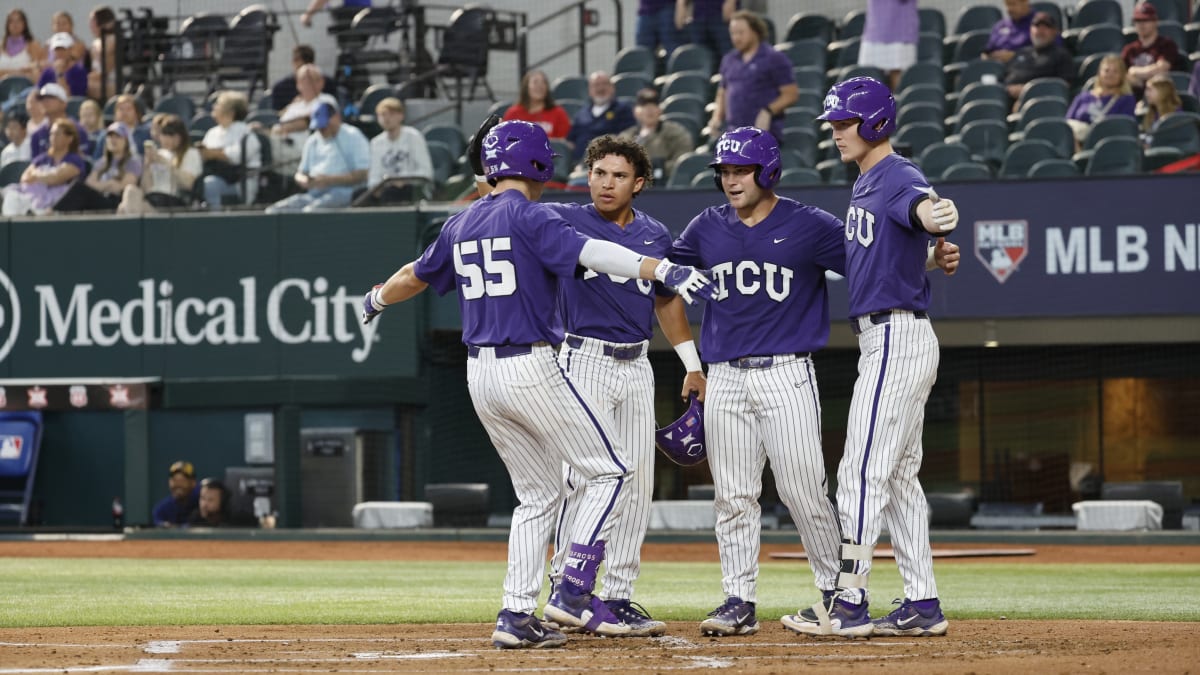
[{"xmin": 846, "ymin": 155, "xmax": 931, "ymax": 317}]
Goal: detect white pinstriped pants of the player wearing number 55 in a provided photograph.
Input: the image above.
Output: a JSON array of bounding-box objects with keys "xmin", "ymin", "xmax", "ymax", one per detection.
[{"xmin": 467, "ymin": 347, "xmax": 629, "ymax": 613}]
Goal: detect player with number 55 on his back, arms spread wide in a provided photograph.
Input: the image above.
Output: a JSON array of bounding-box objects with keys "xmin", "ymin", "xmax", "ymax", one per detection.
[{"xmin": 362, "ymin": 120, "xmax": 712, "ymax": 649}]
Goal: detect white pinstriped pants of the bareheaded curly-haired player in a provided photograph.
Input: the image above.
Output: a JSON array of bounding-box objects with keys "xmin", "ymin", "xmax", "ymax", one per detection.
[{"xmin": 551, "ymin": 340, "xmax": 654, "ymax": 599}]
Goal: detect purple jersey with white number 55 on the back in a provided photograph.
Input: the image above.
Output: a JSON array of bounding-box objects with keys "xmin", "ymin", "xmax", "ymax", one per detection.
[{"xmin": 413, "ymin": 190, "xmax": 587, "ymax": 346}]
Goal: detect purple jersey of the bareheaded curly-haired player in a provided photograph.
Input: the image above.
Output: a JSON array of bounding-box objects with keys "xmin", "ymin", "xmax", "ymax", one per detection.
[{"xmin": 546, "ymin": 204, "xmax": 671, "ymax": 342}]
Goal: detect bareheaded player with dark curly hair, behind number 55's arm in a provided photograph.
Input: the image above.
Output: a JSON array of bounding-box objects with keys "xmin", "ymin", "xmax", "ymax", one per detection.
[{"xmin": 547, "ymin": 136, "xmax": 706, "ymax": 637}]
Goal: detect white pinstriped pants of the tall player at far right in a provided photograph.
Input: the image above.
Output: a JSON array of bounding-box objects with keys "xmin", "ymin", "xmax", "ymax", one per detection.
[{"xmin": 838, "ymin": 312, "xmax": 940, "ymax": 602}]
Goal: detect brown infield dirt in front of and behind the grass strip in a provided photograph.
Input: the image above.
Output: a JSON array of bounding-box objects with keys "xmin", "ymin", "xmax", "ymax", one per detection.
[{"xmin": 0, "ymin": 540, "xmax": 1200, "ymax": 674}]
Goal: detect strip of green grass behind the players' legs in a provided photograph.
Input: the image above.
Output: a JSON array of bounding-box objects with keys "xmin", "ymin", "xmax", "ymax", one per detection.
[{"xmin": 0, "ymin": 557, "xmax": 1200, "ymax": 627}]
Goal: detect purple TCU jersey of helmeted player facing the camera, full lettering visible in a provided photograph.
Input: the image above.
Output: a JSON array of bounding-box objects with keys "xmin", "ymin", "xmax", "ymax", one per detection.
[{"xmin": 670, "ymin": 197, "xmax": 846, "ymax": 363}]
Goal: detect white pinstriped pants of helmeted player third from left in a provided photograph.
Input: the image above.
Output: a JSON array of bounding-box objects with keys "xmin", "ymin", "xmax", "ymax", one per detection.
[{"xmin": 704, "ymin": 356, "xmax": 840, "ymax": 602}]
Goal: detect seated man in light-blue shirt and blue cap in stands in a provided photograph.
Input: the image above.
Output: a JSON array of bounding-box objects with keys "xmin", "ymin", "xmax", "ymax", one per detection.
[{"xmin": 266, "ymin": 97, "xmax": 371, "ymax": 214}]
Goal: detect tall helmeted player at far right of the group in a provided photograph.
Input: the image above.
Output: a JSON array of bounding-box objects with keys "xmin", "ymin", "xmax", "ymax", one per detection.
[{"xmin": 782, "ymin": 77, "xmax": 959, "ymax": 637}]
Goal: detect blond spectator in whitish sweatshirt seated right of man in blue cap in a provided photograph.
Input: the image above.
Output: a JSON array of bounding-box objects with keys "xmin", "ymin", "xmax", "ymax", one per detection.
[{"xmin": 354, "ymin": 96, "xmax": 433, "ymax": 207}]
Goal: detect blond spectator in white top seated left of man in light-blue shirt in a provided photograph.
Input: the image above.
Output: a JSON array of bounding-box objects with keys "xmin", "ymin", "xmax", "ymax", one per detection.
[{"xmin": 199, "ymin": 91, "xmax": 263, "ymax": 211}]
